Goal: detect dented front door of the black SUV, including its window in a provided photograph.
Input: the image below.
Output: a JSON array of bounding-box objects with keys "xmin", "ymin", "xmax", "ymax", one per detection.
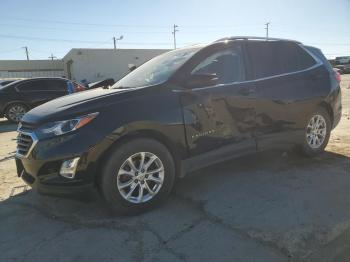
[{"xmin": 181, "ymin": 44, "xmax": 256, "ymax": 158}]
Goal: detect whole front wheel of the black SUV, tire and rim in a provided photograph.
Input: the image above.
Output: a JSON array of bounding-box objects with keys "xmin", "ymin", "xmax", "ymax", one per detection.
[{"xmin": 99, "ymin": 138, "xmax": 175, "ymax": 215}]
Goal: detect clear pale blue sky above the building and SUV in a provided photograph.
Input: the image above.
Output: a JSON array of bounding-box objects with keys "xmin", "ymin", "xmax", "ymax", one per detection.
[{"xmin": 0, "ymin": 0, "xmax": 350, "ymax": 59}]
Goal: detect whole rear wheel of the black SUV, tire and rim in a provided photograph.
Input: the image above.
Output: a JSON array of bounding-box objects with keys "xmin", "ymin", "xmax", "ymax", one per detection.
[{"xmin": 302, "ymin": 107, "xmax": 332, "ymax": 157}]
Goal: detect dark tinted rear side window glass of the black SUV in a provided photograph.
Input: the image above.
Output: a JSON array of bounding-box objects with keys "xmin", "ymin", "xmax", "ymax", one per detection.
[{"xmin": 247, "ymin": 41, "xmax": 316, "ymax": 79}]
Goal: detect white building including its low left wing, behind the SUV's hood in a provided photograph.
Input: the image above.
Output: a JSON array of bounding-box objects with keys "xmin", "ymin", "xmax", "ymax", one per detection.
[{"xmin": 0, "ymin": 48, "xmax": 169, "ymax": 82}]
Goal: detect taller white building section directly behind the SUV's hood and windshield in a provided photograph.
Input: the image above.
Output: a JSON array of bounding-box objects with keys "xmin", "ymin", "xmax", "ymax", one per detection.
[{"xmin": 63, "ymin": 48, "xmax": 169, "ymax": 82}]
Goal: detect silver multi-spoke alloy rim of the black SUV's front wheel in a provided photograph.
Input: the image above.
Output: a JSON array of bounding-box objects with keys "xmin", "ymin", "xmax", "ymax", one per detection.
[{"xmin": 117, "ymin": 152, "xmax": 164, "ymax": 204}]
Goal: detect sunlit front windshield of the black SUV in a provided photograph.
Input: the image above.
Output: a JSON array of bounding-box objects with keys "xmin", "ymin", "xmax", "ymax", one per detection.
[{"xmin": 112, "ymin": 46, "xmax": 200, "ymax": 88}]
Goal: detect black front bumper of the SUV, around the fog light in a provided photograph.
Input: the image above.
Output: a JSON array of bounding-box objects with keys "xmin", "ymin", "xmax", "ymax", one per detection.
[{"xmin": 16, "ymin": 129, "xmax": 108, "ymax": 195}]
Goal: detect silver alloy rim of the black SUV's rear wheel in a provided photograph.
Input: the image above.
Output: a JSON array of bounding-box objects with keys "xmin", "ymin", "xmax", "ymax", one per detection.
[{"xmin": 306, "ymin": 115, "xmax": 327, "ymax": 149}]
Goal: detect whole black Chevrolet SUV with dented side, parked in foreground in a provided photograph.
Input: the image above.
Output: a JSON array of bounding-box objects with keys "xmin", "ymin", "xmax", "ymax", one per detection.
[{"xmin": 16, "ymin": 37, "xmax": 341, "ymax": 213}]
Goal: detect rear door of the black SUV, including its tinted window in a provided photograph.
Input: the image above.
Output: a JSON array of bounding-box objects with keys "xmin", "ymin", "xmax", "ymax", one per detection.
[{"xmin": 247, "ymin": 41, "xmax": 322, "ymax": 149}]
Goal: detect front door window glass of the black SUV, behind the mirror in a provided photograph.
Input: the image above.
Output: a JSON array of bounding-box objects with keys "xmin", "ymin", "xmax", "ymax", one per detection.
[{"xmin": 191, "ymin": 47, "xmax": 244, "ymax": 84}]
